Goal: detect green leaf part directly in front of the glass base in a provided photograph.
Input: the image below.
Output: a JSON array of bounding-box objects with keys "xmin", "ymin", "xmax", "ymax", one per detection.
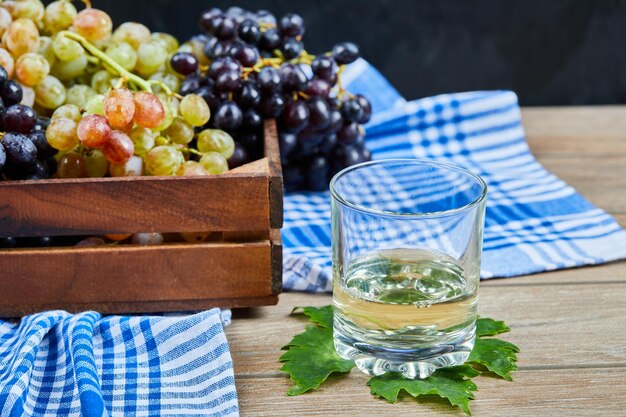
[{"xmin": 367, "ymin": 365, "xmax": 478, "ymax": 414}]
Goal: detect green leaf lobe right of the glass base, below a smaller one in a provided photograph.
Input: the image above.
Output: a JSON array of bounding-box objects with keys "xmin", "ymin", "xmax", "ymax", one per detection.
[{"xmin": 467, "ymin": 337, "xmax": 519, "ymax": 381}]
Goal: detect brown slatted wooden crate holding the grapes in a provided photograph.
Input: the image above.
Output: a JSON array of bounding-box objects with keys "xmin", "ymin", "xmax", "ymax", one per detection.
[{"xmin": 0, "ymin": 122, "xmax": 283, "ymax": 317}]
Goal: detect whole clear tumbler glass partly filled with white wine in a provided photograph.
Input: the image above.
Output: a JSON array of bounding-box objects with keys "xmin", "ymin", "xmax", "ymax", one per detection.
[{"xmin": 330, "ymin": 159, "xmax": 487, "ymax": 379}]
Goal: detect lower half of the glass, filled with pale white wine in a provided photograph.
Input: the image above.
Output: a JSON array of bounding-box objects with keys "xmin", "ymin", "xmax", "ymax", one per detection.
[{"xmin": 333, "ymin": 249, "xmax": 478, "ymax": 378}]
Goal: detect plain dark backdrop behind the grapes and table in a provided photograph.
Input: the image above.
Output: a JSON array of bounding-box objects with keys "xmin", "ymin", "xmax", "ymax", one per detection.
[{"xmin": 80, "ymin": 0, "xmax": 626, "ymax": 105}]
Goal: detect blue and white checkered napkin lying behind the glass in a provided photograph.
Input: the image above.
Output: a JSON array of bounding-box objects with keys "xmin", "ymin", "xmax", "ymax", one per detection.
[{"xmin": 283, "ymin": 60, "xmax": 626, "ymax": 291}]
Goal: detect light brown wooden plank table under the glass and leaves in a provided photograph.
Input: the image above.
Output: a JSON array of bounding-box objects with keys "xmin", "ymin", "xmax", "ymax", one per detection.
[{"xmin": 226, "ymin": 107, "xmax": 626, "ymax": 417}]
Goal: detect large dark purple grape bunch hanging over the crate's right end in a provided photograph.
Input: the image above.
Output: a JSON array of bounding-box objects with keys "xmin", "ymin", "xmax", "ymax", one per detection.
[{"xmin": 170, "ymin": 7, "xmax": 372, "ymax": 191}]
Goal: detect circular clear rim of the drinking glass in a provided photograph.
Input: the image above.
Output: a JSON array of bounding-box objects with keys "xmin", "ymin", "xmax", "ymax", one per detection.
[{"xmin": 330, "ymin": 158, "xmax": 487, "ymax": 218}]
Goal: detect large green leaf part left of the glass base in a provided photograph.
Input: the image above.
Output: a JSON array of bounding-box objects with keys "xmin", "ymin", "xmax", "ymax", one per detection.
[{"xmin": 279, "ymin": 326, "xmax": 354, "ymax": 395}]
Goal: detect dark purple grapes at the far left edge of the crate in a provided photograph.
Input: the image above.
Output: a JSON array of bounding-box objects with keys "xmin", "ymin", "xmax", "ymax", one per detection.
[{"xmin": 0, "ymin": 67, "xmax": 57, "ymax": 180}]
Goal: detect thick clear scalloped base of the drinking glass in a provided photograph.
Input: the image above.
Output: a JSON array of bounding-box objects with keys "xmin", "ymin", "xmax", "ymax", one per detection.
[{"xmin": 334, "ymin": 326, "xmax": 476, "ymax": 379}]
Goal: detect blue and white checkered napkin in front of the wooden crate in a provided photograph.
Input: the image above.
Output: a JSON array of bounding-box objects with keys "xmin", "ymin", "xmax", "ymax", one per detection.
[{"xmin": 0, "ymin": 309, "xmax": 239, "ymax": 417}]
